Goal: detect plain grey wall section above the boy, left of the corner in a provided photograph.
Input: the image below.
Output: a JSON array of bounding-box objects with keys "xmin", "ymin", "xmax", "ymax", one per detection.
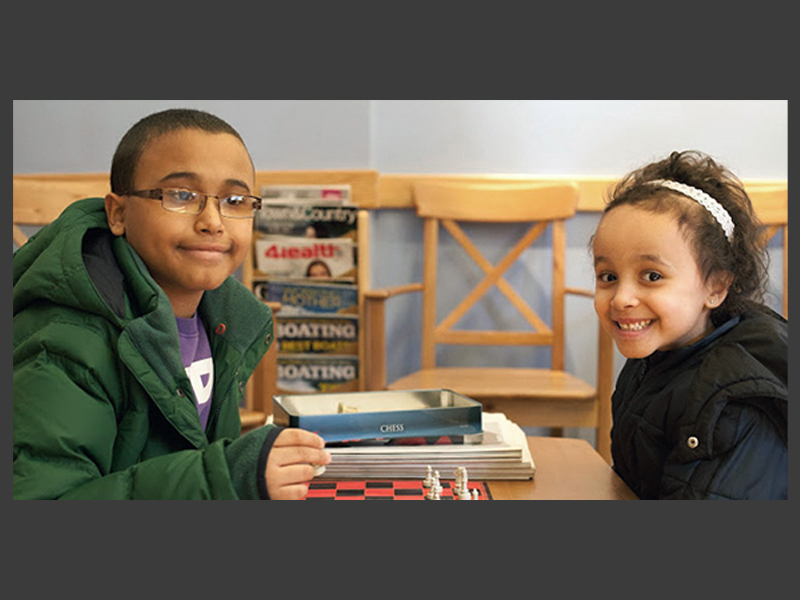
[{"xmin": 14, "ymin": 100, "xmax": 370, "ymax": 173}]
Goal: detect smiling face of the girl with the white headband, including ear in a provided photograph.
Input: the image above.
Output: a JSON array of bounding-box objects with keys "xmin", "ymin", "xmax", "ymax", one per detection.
[{"xmin": 593, "ymin": 205, "xmax": 727, "ymax": 358}]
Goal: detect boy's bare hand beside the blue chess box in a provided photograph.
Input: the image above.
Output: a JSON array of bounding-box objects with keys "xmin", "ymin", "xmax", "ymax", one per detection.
[{"xmin": 264, "ymin": 427, "xmax": 331, "ymax": 500}]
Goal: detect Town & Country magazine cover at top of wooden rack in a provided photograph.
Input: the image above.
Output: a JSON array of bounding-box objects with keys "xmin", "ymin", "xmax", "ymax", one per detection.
[{"xmin": 256, "ymin": 203, "xmax": 358, "ymax": 240}]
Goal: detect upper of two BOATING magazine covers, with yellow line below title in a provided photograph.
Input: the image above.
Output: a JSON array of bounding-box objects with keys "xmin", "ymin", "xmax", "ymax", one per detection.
[{"xmin": 275, "ymin": 316, "xmax": 358, "ymax": 355}]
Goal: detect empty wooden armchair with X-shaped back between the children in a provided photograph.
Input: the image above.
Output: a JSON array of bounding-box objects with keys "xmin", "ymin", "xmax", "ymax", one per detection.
[{"xmin": 365, "ymin": 181, "xmax": 613, "ymax": 462}]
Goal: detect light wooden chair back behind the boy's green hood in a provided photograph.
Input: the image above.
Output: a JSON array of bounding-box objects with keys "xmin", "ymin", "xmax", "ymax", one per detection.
[{"xmin": 12, "ymin": 173, "xmax": 110, "ymax": 247}]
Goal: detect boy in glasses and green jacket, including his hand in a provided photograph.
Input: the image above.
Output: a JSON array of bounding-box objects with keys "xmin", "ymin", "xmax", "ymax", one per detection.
[{"xmin": 13, "ymin": 109, "xmax": 330, "ymax": 499}]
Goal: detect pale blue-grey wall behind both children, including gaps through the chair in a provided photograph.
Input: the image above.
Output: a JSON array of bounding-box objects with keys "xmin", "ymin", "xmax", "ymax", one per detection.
[{"xmin": 13, "ymin": 100, "xmax": 788, "ymax": 435}]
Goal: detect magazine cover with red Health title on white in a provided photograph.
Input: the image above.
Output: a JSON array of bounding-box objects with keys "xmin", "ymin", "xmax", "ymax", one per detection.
[{"xmin": 256, "ymin": 235, "xmax": 356, "ymax": 280}]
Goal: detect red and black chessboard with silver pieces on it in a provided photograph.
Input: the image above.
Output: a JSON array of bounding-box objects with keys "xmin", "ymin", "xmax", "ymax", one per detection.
[{"xmin": 305, "ymin": 467, "xmax": 492, "ymax": 500}]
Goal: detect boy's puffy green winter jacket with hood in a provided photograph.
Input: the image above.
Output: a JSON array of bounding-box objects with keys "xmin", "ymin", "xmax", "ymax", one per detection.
[{"xmin": 13, "ymin": 198, "xmax": 278, "ymax": 499}]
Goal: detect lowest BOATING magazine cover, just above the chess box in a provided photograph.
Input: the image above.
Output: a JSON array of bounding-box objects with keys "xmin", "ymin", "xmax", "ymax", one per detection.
[{"xmin": 277, "ymin": 354, "xmax": 358, "ymax": 394}]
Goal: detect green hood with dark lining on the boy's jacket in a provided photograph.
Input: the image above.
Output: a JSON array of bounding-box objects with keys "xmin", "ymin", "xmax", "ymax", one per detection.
[{"xmin": 13, "ymin": 198, "xmax": 158, "ymax": 324}]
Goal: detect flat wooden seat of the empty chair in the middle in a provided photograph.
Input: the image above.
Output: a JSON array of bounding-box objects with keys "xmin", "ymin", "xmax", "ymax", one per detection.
[{"xmin": 388, "ymin": 367, "xmax": 597, "ymax": 427}]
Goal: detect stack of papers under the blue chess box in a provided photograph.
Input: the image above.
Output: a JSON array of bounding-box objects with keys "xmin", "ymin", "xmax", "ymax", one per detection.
[{"xmin": 323, "ymin": 413, "xmax": 536, "ymax": 480}]
